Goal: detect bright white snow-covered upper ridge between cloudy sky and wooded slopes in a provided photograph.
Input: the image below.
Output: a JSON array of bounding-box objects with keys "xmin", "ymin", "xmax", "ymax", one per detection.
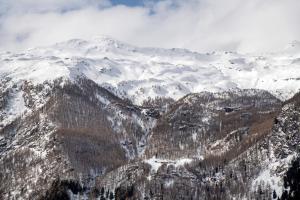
[{"xmin": 0, "ymin": 37, "xmax": 300, "ymax": 105}]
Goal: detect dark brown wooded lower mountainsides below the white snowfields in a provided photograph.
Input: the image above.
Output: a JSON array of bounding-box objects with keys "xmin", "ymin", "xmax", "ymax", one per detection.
[{"xmin": 0, "ymin": 74, "xmax": 300, "ymax": 200}]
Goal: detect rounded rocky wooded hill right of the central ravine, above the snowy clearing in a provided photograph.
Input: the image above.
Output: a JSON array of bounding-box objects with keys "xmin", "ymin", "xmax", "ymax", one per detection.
[{"xmin": 146, "ymin": 90, "xmax": 281, "ymax": 158}]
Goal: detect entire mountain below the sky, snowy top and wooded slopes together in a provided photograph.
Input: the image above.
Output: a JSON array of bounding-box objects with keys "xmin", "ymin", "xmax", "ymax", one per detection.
[{"xmin": 0, "ymin": 37, "xmax": 300, "ymax": 200}]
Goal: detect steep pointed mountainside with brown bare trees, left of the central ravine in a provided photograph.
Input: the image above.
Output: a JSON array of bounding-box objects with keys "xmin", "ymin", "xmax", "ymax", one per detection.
[{"xmin": 0, "ymin": 79, "xmax": 155, "ymax": 199}]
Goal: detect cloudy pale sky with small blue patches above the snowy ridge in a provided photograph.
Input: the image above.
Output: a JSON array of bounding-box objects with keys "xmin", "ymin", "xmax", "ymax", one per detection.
[{"xmin": 0, "ymin": 0, "xmax": 300, "ymax": 52}]
